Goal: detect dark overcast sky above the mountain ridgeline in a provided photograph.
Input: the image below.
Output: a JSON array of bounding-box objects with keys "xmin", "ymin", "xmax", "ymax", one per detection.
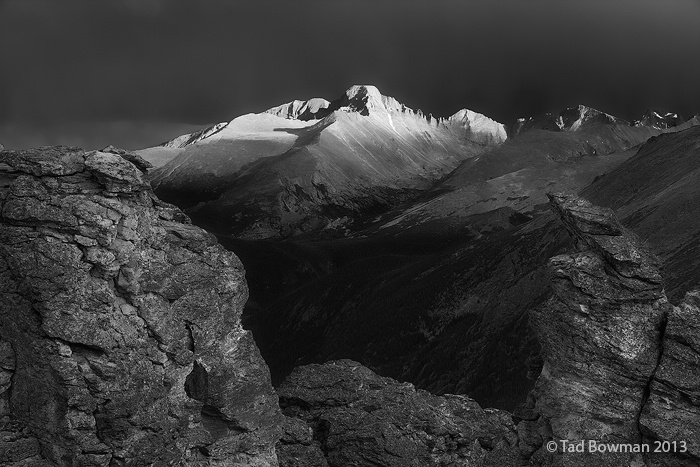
[{"xmin": 0, "ymin": 0, "xmax": 700, "ymax": 149}]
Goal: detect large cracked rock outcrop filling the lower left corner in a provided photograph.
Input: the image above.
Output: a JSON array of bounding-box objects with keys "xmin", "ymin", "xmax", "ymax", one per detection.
[{"xmin": 0, "ymin": 147, "xmax": 282, "ymax": 466}]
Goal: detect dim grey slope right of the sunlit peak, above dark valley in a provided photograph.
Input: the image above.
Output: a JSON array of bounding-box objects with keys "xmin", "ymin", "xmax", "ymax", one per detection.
[{"xmin": 366, "ymin": 123, "xmax": 660, "ymax": 238}]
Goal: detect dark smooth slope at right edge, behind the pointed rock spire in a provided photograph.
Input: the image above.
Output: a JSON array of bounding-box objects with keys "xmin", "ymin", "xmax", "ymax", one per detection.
[{"xmin": 581, "ymin": 126, "xmax": 700, "ymax": 300}]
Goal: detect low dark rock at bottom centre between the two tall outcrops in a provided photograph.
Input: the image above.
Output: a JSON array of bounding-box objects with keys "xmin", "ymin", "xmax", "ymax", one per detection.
[{"xmin": 278, "ymin": 360, "xmax": 520, "ymax": 467}]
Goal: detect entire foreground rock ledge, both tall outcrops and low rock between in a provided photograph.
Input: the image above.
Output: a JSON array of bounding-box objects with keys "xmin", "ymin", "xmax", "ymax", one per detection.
[{"xmin": 0, "ymin": 147, "xmax": 700, "ymax": 467}]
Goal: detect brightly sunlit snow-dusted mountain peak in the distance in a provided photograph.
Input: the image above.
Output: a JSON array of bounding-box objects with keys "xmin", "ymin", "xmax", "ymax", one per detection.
[{"xmin": 139, "ymin": 86, "xmax": 505, "ymax": 238}]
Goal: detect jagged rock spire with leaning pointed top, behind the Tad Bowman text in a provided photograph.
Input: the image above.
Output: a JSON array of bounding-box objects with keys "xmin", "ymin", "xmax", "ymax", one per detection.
[{"xmin": 518, "ymin": 194, "xmax": 700, "ymax": 466}]
